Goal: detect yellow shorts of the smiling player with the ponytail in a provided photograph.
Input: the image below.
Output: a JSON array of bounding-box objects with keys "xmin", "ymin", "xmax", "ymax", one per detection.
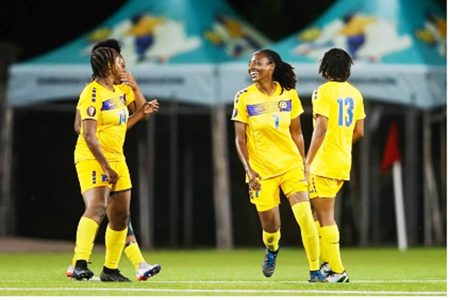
[{"xmin": 249, "ymin": 168, "xmax": 308, "ymax": 211}]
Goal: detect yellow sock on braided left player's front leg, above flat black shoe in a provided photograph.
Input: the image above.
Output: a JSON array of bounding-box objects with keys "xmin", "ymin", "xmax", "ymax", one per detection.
[{"xmin": 105, "ymin": 225, "xmax": 128, "ymax": 269}]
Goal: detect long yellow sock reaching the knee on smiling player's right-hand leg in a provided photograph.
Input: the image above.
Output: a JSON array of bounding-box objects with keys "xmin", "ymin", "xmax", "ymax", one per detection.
[{"xmin": 292, "ymin": 201, "xmax": 320, "ymax": 271}]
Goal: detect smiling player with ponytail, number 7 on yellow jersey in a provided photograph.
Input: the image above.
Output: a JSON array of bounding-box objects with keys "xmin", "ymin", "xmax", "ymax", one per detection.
[{"xmin": 232, "ymin": 49, "xmax": 323, "ymax": 282}]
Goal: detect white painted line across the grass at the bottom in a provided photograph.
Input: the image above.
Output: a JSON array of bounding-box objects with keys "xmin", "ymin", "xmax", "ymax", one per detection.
[{"xmin": 0, "ymin": 287, "xmax": 447, "ymax": 296}]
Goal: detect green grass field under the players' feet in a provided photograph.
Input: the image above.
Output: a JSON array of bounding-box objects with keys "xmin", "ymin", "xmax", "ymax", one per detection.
[{"xmin": 0, "ymin": 248, "xmax": 447, "ymax": 296}]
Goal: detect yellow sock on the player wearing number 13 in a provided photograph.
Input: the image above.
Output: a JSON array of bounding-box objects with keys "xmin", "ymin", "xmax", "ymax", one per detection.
[{"xmin": 320, "ymin": 225, "xmax": 344, "ymax": 273}]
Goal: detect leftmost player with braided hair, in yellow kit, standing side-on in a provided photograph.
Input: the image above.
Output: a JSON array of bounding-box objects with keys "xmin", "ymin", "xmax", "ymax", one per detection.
[{"xmin": 72, "ymin": 47, "xmax": 158, "ymax": 281}]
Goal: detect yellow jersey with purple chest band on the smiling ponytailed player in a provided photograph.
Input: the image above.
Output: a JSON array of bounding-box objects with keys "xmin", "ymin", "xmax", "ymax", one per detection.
[{"xmin": 231, "ymin": 82, "xmax": 303, "ymax": 179}]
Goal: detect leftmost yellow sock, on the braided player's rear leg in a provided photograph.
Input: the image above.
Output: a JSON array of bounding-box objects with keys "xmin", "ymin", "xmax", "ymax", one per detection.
[{"xmin": 72, "ymin": 217, "xmax": 98, "ymax": 266}]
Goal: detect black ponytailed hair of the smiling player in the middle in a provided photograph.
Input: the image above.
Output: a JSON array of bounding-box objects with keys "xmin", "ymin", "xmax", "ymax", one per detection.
[{"xmin": 258, "ymin": 49, "xmax": 297, "ymax": 93}]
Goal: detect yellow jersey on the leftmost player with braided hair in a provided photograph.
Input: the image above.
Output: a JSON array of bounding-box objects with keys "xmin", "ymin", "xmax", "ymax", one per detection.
[{"xmin": 74, "ymin": 81, "xmax": 135, "ymax": 163}]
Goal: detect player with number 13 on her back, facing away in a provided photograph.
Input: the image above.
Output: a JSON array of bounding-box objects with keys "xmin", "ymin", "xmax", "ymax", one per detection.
[{"xmin": 306, "ymin": 48, "xmax": 366, "ymax": 282}]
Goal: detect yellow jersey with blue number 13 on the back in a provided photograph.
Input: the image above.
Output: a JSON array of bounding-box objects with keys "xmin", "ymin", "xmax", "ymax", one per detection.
[{"xmin": 310, "ymin": 81, "xmax": 366, "ymax": 180}]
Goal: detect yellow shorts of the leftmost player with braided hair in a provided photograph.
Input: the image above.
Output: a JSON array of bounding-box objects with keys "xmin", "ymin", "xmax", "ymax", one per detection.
[{"xmin": 75, "ymin": 159, "xmax": 132, "ymax": 193}]
